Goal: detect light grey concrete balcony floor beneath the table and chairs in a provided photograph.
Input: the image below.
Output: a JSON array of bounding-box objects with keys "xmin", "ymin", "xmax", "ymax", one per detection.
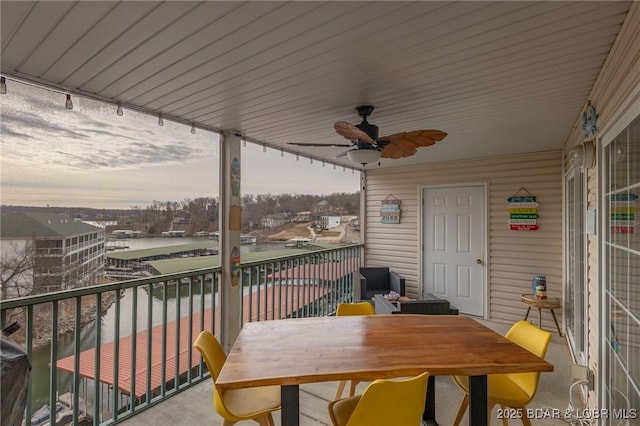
[{"xmin": 122, "ymin": 313, "xmax": 578, "ymax": 426}]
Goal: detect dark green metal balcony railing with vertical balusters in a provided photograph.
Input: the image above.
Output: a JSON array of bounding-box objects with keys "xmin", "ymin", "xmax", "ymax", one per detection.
[{"xmin": 0, "ymin": 245, "xmax": 362, "ymax": 426}]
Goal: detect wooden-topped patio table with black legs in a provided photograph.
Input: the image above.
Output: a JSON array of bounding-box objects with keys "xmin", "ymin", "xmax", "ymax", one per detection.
[{"xmin": 216, "ymin": 315, "xmax": 553, "ymax": 426}]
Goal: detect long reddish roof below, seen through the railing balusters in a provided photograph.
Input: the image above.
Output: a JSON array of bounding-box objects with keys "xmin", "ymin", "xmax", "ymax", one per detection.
[{"xmin": 56, "ymin": 284, "xmax": 329, "ymax": 402}]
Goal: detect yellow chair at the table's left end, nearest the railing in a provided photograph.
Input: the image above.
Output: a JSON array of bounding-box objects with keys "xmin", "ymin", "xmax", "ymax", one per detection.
[{"xmin": 193, "ymin": 330, "xmax": 280, "ymax": 426}]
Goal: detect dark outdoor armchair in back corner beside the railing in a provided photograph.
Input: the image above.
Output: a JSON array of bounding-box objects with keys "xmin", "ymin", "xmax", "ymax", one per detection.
[{"xmin": 353, "ymin": 267, "xmax": 405, "ymax": 302}]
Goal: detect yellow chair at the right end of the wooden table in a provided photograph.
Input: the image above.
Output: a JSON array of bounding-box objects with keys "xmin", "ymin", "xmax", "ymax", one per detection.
[{"xmin": 453, "ymin": 321, "xmax": 551, "ymax": 426}]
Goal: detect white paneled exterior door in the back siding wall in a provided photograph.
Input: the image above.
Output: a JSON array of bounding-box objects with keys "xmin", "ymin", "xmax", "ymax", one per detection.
[{"xmin": 422, "ymin": 186, "xmax": 486, "ymax": 317}]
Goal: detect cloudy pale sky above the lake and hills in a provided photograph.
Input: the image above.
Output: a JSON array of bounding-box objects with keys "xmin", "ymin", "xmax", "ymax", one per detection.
[{"xmin": 0, "ymin": 81, "xmax": 360, "ymax": 208}]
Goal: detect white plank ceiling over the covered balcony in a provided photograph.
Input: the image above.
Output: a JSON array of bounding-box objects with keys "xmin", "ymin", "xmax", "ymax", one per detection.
[{"xmin": 0, "ymin": 0, "xmax": 629, "ymax": 167}]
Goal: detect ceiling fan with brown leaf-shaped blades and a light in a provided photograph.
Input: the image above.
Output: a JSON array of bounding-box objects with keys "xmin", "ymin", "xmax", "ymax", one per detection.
[{"xmin": 290, "ymin": 105, "xmax": 447, "ymax": 166}]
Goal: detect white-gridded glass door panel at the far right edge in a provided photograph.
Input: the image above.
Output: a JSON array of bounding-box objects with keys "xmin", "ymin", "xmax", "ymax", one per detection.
[{"xmin": 601, "ymin": 117, "xmax": 640, "ymax": 425}]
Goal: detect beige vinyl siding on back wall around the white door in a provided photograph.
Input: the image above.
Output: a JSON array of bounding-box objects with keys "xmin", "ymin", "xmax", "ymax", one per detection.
[{"xmin": 364, "ymin": 148, "xmax": 563, "ymax": 330}]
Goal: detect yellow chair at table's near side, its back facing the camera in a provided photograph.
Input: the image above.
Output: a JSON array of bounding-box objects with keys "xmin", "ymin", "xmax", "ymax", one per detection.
[{"xmin": 329, "ymin": 372, "xmax": 429, "ymax": 426}]
